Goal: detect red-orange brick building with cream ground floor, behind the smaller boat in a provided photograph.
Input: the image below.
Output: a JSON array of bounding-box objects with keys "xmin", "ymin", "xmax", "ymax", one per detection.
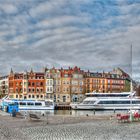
[{"xmin": 8, "ymin": 70, "xmax": 45, "ymax": 100}]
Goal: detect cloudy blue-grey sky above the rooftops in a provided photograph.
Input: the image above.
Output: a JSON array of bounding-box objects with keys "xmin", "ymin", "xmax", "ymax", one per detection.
[{"xmin": 0, "ymin": 0, "xmax": 140, "ymax": 81}]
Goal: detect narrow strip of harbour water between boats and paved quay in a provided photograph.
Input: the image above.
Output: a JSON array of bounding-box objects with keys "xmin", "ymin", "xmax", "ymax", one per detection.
[{"xmin": 20, "ymin": 110, "xmax": 127, "ymax": 116}]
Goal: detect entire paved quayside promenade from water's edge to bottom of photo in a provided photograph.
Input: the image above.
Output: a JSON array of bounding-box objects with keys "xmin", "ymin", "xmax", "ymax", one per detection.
[{"xmin": 0, "ymin": 112, "xmax": 140, "ymax": 140}]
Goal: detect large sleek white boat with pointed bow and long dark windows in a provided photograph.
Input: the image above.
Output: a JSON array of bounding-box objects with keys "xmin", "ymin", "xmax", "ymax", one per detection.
[{"xmin": 71, "ymin": 97, "xmax": 140, "ymax": 110}]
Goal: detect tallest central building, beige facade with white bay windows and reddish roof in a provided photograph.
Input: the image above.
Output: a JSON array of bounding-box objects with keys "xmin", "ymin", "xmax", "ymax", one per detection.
[{"xmin": 45, "ymin": 67, "xmax": 85, "ymax": 104}]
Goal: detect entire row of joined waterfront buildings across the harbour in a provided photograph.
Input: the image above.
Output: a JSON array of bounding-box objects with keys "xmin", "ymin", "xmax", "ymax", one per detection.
[{"xmin": 0, "ymin": 66, "xmax": 131, "ymax": 104}]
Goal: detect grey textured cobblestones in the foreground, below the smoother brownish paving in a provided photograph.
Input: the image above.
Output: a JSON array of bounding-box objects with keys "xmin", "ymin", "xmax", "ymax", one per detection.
[{"xmin": 22, "ymin": 121, "xmax": 140, "ymax": 140}]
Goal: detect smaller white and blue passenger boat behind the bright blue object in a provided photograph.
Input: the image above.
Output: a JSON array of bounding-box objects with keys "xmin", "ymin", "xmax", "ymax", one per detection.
[{"xmin": 2, "ymin": 99, "xmax": 55, "ymax": 111}]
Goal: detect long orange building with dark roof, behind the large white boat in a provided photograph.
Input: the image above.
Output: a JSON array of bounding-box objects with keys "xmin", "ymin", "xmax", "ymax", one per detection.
[{"xmin": 85, "ymin": 71, "xmax": 130, "ymax": 93}]
